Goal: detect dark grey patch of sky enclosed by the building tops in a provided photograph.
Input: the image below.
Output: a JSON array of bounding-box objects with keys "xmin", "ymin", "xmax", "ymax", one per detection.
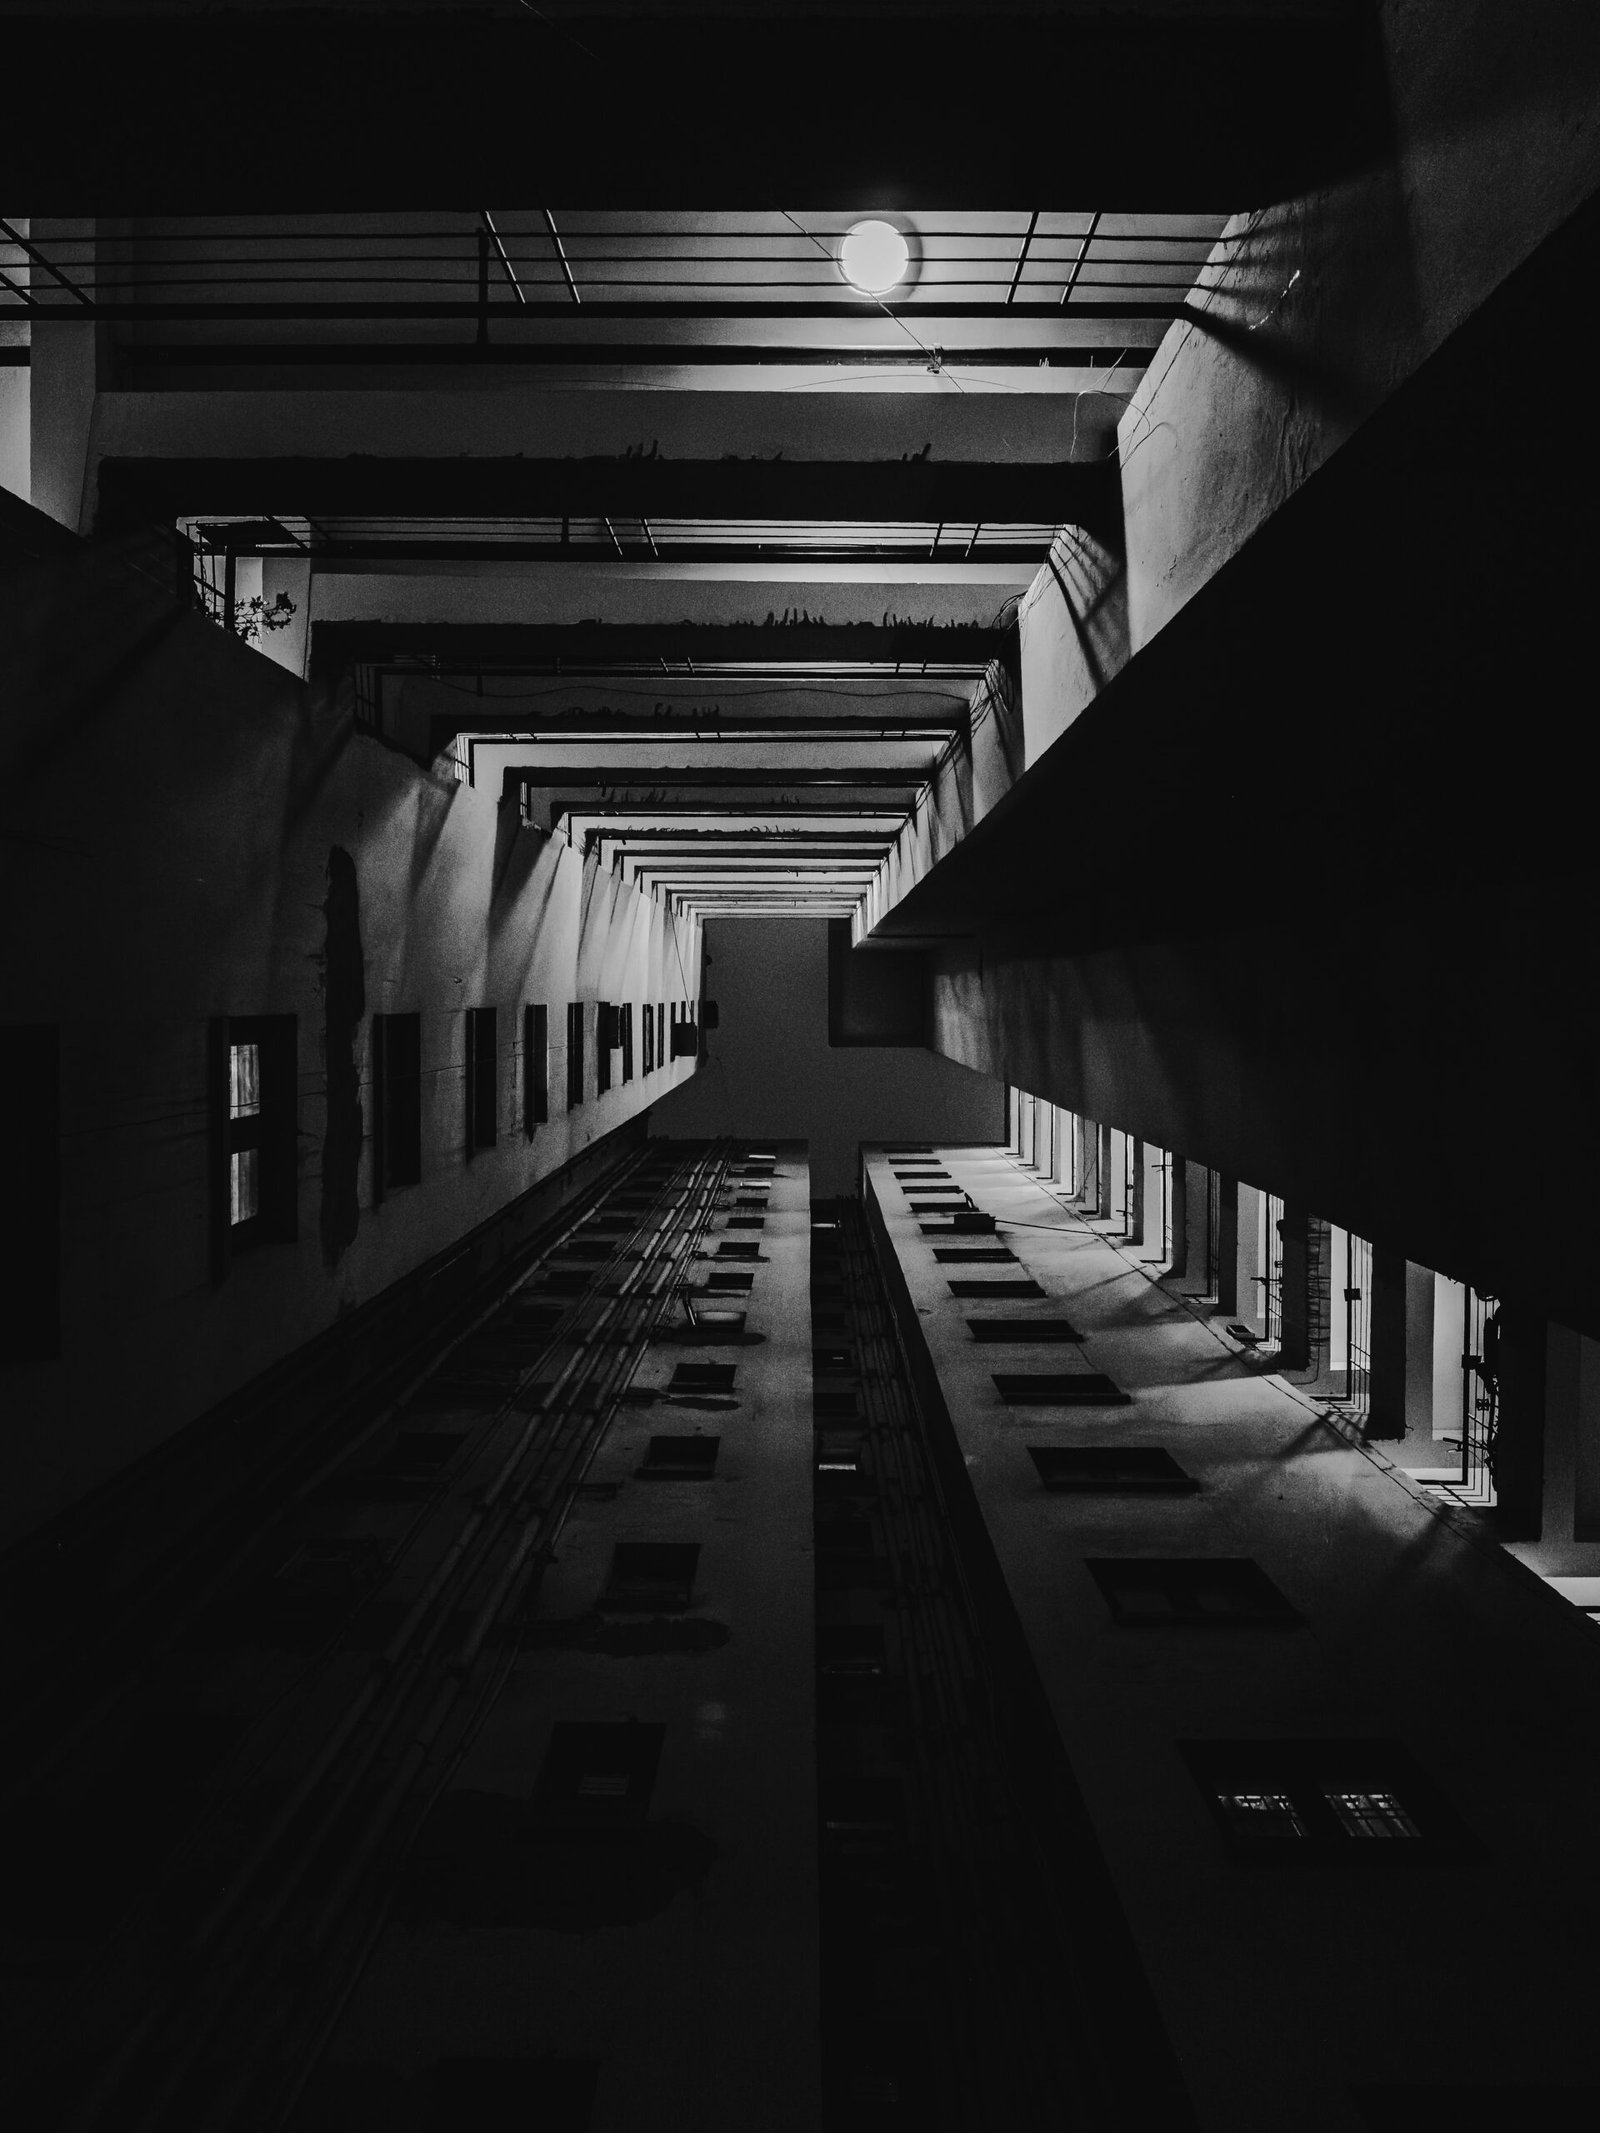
[{"xmin": 651, "ymin": 919, "xmax": 1005, "ymax": 1199}]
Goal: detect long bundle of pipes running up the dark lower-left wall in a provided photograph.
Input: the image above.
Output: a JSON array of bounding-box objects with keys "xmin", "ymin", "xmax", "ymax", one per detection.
[{"xmin": 68, "ymin": 1148, "xmax": 730, "ymax": 2129}]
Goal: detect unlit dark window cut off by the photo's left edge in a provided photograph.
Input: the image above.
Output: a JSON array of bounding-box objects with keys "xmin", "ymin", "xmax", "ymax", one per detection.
[{"xmin": 0, "ymin": 1022, "xmax": 62, "ymax": 1363}]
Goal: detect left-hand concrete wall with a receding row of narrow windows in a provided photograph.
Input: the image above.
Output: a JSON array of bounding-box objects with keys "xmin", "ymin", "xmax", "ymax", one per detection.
[{"xmin": 0, "ymin": 524, "xmax": 700, "ymax": 1534}]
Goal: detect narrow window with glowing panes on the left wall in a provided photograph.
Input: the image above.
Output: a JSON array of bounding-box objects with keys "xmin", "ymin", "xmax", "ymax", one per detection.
[{"xmin": 211, "ymin": 1015, "xmax": 299, "ymax": 1273}]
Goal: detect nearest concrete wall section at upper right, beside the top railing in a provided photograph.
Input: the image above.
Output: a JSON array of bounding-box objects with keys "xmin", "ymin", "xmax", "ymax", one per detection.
[{"xmin": 1118, "ymin": 0, "xmax": 1600, "ymax": 653}]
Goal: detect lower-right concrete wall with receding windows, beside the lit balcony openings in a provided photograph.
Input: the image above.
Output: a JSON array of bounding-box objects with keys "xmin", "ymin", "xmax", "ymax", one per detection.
[{"xmin": 868, "ymin": 1148, "xmax": 1600, "ymax": 2133}]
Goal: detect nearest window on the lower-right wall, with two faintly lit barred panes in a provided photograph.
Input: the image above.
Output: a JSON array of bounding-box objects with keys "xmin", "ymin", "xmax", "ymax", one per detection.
[{"xmin": 1180, "ymin": 1741, "xmax": 1466, "ymax": 1862}]
